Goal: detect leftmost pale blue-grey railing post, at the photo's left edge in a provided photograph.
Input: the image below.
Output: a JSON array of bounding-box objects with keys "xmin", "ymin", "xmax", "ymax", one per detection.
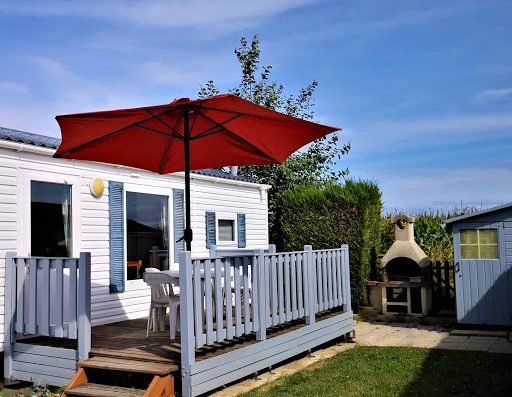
[{"xmin": 4, "ymin": 252, "xmax": 16, "ymax": 379}]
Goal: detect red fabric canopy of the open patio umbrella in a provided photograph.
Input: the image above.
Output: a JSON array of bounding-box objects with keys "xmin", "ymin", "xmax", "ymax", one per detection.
[{"xmin": 55, "ymin": 94, "xmax": 339, "ymax": 174}]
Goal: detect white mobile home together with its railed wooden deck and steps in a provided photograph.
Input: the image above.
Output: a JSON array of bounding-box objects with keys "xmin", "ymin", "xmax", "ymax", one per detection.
[{"xmin": 0, "ymin": 128, "xmax": 353, "ymax": 396}]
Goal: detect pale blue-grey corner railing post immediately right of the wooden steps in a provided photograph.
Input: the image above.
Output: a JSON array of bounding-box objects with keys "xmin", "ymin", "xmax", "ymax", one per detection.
[{"xmin": 179, "ymin": 251, "xmax": 195, "ymax": 397}]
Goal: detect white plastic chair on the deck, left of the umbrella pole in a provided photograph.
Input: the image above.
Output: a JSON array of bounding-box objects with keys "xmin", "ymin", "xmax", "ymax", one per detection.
[{"xmin": 143, "ymin": 268, "xmax": 180, "ymax": 339}]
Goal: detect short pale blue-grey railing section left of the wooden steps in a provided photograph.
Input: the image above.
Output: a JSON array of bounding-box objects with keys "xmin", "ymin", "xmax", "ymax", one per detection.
[{"xmin": 5, "ymin": 253, "xmax": 91, "ymax": 358}]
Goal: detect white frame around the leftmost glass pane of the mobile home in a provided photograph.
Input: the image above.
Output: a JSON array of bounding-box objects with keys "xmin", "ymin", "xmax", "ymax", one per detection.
[{"xmin": 18, "ymin": 169, "xmax": 82, "ymax": 258}]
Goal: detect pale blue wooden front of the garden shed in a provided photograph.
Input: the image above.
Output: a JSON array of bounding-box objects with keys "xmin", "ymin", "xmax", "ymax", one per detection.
[{"xmin": 455, "ymin": 223, "xmax": 512, "ymax": 325}]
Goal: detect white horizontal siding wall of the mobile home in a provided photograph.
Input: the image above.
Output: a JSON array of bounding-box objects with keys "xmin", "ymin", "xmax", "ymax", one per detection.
[{"xmin": 0, "ymin": 148, "xmax": 268, "ymax": 350}]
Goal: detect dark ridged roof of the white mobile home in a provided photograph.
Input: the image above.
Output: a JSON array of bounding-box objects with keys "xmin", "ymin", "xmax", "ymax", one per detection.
[{"xmin": 0, "ymin": 127, "xmax": 256, "ymax": 183}]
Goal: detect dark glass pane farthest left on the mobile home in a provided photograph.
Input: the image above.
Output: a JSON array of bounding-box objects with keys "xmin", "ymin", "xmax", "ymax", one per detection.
[{"xmin": 30, "ymin": 181, "xmax": 72, "ymax": 257}]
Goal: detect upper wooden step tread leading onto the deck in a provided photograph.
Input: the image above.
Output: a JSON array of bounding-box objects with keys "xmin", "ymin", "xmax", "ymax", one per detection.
[{"xmin": 78, "ymin": 356, "xmax": 178, "ymax": 375}]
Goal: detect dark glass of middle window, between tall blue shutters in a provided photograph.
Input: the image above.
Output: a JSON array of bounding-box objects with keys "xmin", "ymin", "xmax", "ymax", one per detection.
[{"xmin": 126, "ymin": 192, "xmax": 169, "ymax": 280}]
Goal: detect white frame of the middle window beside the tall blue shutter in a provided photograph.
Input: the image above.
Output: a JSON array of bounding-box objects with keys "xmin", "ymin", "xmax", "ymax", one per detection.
[{"xmin": 123, "ymin": 182, "xmax": 174, "ymax": 287}]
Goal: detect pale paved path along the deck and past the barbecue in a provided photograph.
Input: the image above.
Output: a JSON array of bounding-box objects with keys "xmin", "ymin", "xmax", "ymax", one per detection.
[{"xmin": 212, "ymin": 321, "xmax": 512, "ymax": 397}]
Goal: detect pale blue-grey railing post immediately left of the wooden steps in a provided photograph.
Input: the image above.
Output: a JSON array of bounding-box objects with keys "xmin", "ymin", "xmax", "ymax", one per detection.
[{"xmin": 77, "ymin": 252, "xmax": 91, "ymax": 360}]
